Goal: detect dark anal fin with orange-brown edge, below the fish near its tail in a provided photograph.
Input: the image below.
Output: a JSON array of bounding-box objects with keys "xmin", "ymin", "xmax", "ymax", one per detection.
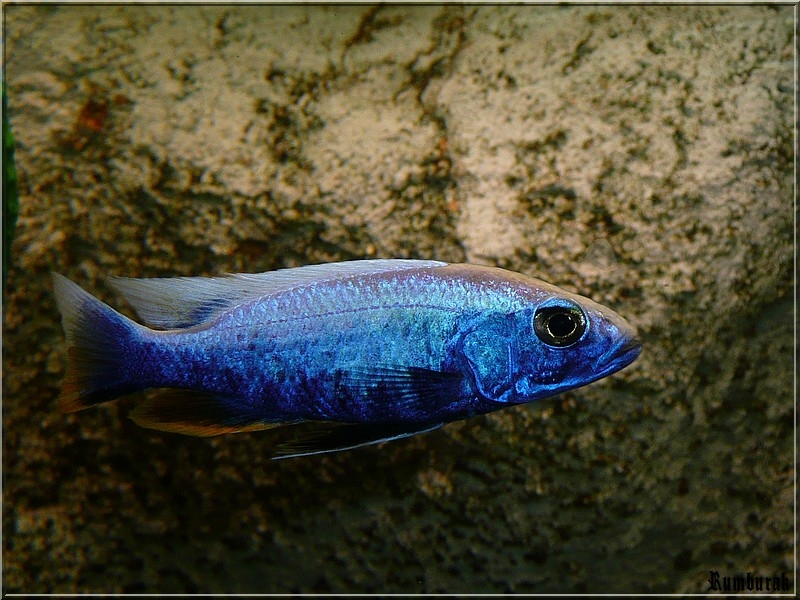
[{"xmin": 129, "ymin": 388, "xmax": 287, "ymax": 437}]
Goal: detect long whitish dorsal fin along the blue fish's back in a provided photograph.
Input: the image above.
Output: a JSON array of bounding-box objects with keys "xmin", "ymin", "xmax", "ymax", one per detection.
[{"xmin": 110, "ymin": 259, "xmax": 447, "ymax": 329}]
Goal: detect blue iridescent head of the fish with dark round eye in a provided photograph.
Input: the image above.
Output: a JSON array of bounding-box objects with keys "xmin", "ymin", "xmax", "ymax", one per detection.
[{"xmin": 462, "ymin": 290, "xmax": 641, "ymax": 404}]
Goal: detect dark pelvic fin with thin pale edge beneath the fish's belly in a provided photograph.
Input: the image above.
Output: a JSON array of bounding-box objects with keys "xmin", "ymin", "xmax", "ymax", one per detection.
[{"xmin": 272, "ymin": 423, "xmax": 442, "ymax": 460}]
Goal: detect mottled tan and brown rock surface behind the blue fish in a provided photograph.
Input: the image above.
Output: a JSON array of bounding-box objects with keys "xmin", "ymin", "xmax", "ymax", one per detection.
[{"xmin": 3, "ymin": 6, "xmax": 794, "ymax": 593}]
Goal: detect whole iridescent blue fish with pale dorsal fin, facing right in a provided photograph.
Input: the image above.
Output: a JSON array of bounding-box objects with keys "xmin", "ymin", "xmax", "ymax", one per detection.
[{"xmin": 53, "ymin": 260, "xmax": 641, "ymax": 458}]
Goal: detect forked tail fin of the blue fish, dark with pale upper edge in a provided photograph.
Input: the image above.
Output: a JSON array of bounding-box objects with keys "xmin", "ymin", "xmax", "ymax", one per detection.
[{"xmin": 53, "ymin": 273, "xmax": 141, "ymax": 412}]
